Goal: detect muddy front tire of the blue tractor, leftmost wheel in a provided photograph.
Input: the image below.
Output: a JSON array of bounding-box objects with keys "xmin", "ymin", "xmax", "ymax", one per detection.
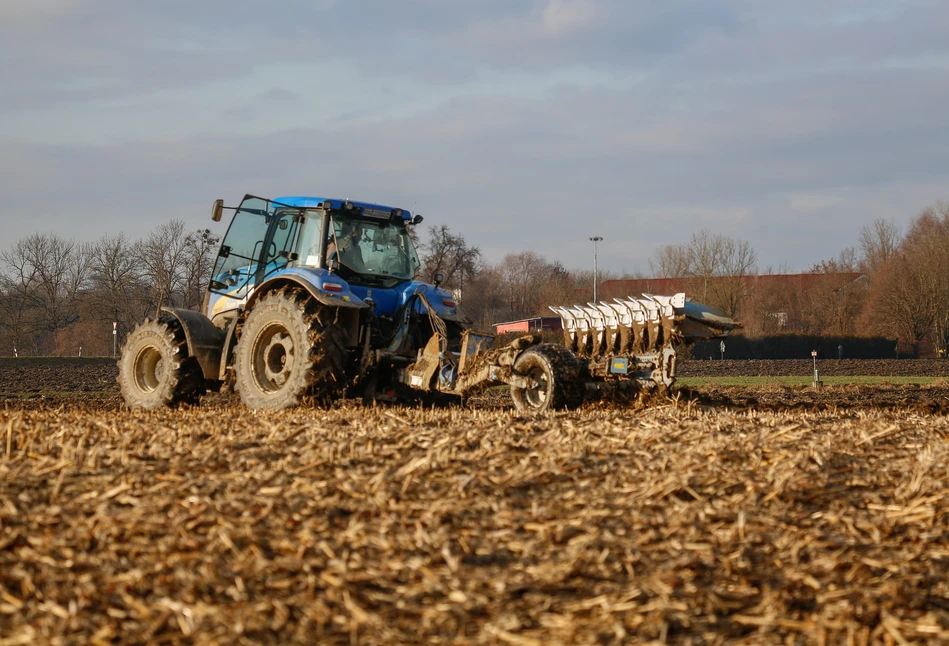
[{"xmin": 118, "ymin": 315, "xmax": 205, "ymax": 410}]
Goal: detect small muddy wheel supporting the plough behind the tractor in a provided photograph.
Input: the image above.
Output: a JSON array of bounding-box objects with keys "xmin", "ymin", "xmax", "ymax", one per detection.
[{"xmin": 511, "ymin": 343, "xmax": 580, "ymax": 415}]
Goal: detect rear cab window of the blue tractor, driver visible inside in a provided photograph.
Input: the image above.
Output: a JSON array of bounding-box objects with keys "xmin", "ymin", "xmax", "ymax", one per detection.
[{"xmin": 326, "ymin": 213, "xmax": 420, "ymax": 285}]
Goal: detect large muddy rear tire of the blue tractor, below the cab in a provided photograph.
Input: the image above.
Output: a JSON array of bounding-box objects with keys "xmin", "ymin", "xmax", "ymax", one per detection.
[{"xmin": 234, "ymin": 288, "xmax": 347, "ymax": 410}]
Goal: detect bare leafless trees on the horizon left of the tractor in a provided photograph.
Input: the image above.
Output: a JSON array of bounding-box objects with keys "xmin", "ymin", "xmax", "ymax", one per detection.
[{"xmin": 0, "ymin": 220, "xmax": 219, "ymax": 356}]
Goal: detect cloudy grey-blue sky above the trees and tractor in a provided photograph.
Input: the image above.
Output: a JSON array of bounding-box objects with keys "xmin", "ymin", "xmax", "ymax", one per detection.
[{"xmin": 0, "ymin": 0, "xmax": 949, "ymax": 273}]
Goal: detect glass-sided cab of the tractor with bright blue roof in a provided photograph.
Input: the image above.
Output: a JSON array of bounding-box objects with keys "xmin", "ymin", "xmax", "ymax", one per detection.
[{"xmin": 205, "ymin": 195, "xmax": 422, "ymax": 319}]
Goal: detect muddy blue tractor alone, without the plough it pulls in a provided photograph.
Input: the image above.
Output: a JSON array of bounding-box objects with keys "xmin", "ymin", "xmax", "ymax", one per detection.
[{"xmin": 119, "ymin": 195, "xmax": 560, "ymax": 409}]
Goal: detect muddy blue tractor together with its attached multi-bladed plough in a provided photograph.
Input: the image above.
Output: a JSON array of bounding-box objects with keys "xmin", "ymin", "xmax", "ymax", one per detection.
[{"xmin": 118, "ymin": 195, "xmax": 737, "ymax": 414}]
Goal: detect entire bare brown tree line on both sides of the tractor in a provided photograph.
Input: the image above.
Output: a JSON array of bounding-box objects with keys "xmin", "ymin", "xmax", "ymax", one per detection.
[{"xmin": 0, "ymin": 202, "xmax": 949, "ymax": 356}]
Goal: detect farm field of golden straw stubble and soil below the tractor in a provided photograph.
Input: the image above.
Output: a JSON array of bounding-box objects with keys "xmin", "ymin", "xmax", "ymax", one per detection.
[{"xmin": 0, "ymin": 362, "xmax": 949, "ymax": 644}]
